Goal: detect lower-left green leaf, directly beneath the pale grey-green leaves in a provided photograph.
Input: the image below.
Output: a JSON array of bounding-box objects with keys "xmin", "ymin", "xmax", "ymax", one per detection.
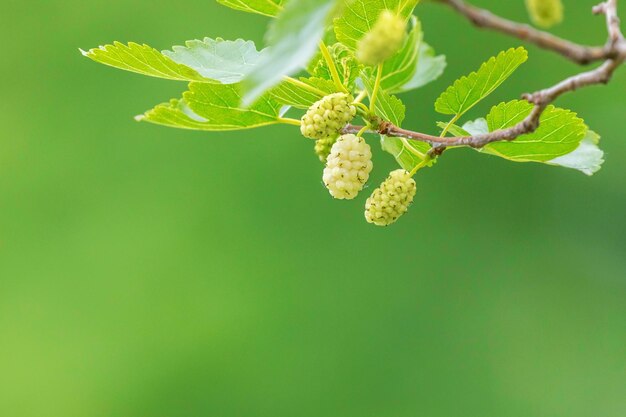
[{"xmin": 137, "ymin": 82, "xmax": 282, "ymax": 131}]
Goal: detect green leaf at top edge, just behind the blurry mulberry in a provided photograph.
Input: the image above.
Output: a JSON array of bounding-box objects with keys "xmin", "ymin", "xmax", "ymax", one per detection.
[{"xmin": 335, "ymin": 0, "xmax": 419, "ymax": 48}]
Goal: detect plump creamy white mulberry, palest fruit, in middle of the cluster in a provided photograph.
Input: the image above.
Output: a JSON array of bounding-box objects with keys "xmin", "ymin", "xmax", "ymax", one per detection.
[{"xmin": 323, "ymin": 135, "xmax": 372, "ymax": 200}]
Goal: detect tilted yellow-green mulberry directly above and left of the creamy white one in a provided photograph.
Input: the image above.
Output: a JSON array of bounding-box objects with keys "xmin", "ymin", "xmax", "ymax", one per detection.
[{"xmin": 300, "ymin": 93, "xmax": 356, "ymax": 139}]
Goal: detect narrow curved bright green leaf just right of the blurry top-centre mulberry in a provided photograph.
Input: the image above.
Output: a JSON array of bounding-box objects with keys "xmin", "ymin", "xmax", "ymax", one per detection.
[{"xmin": 381, "ymin": 16, "xmax": 423, "ymax": 93}]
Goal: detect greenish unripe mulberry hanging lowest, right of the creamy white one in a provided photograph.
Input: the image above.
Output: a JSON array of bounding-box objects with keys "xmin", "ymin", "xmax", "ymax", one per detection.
[{"xmin": 365, "ymin": 169, "xmax": 417, "ymax": 226}]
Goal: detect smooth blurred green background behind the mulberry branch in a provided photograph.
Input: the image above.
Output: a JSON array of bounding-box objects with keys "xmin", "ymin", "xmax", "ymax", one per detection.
[{"xmin": 0, "ymin": 0, "xmax": 626, "ymax": 417}]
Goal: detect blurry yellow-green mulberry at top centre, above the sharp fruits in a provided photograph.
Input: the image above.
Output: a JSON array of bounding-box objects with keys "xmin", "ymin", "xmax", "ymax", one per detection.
[{"xmin": 357, "ymin": 10, "xmax": 407, "ymax": 66}]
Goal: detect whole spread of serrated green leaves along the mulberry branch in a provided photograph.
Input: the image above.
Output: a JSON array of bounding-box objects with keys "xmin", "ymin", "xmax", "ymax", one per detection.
[{"xmin": 83, "ymin": 0, "xmax": 603, "ymax": 182}]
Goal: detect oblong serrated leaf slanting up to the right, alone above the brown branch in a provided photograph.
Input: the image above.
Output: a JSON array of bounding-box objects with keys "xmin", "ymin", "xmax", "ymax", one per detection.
[{"xmin": 435, "ymin": 47, "xmax": 528, "ymax": 117}]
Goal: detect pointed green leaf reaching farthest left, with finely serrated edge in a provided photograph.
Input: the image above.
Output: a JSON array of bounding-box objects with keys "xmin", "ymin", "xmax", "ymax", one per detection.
[{"xmin": 81, "ymin": 42, "xmax": 207, "ymax": 82}]
